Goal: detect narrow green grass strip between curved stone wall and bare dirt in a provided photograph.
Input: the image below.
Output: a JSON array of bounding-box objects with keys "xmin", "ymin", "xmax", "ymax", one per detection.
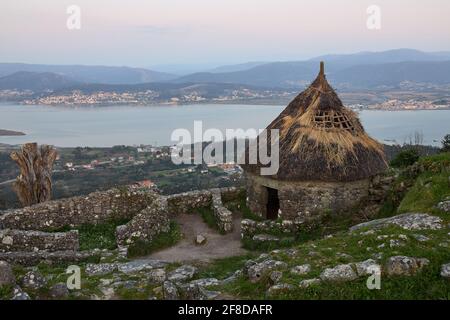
[{"xmin": 128, "ymin": 221, "xmax": 183, "ymax": 258}]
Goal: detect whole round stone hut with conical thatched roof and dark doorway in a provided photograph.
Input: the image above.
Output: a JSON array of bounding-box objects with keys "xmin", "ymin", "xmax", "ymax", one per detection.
[{"xmin": 243, "ymin": 62, "xmax": 387, "ymax": 223}]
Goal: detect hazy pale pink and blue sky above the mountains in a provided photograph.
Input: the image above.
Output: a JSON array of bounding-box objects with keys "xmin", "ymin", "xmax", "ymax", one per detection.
[{"xmin": 0, "ymin": 0, "xmax": 450, "ymax": 66}]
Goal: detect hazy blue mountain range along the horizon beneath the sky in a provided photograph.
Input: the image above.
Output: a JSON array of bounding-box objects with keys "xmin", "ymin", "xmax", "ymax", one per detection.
[{"xmin": 0, "ymin": 49, "xmax": 450, "ymax": 92}]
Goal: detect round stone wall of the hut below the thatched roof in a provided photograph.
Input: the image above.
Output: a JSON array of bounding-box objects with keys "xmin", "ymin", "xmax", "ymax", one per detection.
[{"xmin": 246, "ymin": 173, "xmax": 370, "ymax": 224}]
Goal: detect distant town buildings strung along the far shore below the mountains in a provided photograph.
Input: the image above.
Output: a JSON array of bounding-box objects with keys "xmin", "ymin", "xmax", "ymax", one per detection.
[{"xmin": 0, "ymin": 83, "xmax": 450, "ymax": 111}]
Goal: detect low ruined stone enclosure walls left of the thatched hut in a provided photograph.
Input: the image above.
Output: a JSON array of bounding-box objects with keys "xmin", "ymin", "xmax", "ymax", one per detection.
[{"xmin": 0, "ymin": 187, "xmax": 241, "ymax": 265}]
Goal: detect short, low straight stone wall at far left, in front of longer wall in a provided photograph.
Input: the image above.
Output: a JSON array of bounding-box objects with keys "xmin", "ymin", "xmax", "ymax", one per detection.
[{"xmin": 0, "ymin": 229, "xmax": 79, "ymax": 252}]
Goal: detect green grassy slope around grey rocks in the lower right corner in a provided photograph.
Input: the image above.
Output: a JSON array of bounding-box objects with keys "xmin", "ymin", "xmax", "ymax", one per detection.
[{"xmin": 216, "ymin": 222, "xmax": 450, "ymax": 300}]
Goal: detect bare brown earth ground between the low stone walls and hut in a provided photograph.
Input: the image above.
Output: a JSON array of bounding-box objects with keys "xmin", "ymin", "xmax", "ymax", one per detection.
[{"xmin": 140, "ymin": 214, "xmax": 247, "ymax": 262}]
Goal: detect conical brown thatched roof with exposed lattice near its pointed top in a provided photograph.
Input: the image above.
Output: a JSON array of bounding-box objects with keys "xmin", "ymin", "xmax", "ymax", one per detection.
[{"xmin": 243, "ymin": 62, "xmax": 387, "ymax": 181}]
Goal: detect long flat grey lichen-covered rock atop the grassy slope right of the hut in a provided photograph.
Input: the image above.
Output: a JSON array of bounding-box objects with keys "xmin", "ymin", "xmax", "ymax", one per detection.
[{"xmin": 350, "ymin": 213, "xmax": 443, "ymax": 231}]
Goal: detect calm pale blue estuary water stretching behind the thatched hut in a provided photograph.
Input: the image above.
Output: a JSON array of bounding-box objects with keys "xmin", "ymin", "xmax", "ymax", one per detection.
[{"xmin": 0, "ymin": 104, "xmax": 450, "ymax": 147}]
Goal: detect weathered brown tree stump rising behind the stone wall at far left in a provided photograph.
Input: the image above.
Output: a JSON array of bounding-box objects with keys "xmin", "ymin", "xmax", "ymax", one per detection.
[{"xmin": 11, "ymin": 143, "xmax": 57, "ymax": 207}]
